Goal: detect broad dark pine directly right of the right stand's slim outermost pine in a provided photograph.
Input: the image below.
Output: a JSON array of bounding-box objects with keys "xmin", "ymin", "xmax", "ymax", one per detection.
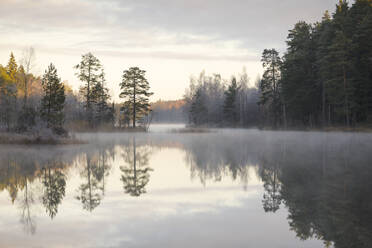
[{"xmin": 280, "ymin": 22, "xmax": 321, "ymax": 127}]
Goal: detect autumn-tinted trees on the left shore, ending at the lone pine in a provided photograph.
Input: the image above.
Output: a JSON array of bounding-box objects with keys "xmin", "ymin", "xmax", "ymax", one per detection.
[{"xmin": 0, "ymin": 48, "xmax": 152, "ymax": 135}]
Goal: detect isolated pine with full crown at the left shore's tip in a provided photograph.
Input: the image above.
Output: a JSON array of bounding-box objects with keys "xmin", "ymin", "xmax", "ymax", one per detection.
[{"xmin": 119, "ymin": 67, "xmax": 153, "ymax": 128}]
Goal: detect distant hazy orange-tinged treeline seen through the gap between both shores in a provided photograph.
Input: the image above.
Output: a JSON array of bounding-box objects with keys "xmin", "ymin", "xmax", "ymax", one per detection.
[{"xmin": 151, "ymin": 100, "xmax": 186, "ymax": 123}]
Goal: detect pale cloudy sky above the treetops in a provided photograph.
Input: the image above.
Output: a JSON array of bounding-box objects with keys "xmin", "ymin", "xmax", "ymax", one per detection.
[{"xmin": 0, "ymin": 0, "xmax": 337, "ymax": 101}]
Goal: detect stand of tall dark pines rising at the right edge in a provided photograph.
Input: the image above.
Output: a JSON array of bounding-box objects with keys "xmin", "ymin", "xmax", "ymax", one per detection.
[{"xmin": 259, "ymin": 0, "xmax": 372, "ymax": 128}]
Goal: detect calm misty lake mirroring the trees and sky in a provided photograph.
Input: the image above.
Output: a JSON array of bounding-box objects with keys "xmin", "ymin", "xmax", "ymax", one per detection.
[{"xmin": 0, "ymin": 125, "xmax": 372, "ymax": 248}]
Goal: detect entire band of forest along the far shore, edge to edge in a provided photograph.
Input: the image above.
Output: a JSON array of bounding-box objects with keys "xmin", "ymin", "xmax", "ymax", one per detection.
[{"xmin": 0, "ymin": 0, "xmax": 372, "ymax": 135}]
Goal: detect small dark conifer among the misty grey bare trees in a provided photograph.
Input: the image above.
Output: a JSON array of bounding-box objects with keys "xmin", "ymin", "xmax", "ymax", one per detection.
[{"xmin": 223, "ymin": 77, "xmax": 239, "ymax": 125}]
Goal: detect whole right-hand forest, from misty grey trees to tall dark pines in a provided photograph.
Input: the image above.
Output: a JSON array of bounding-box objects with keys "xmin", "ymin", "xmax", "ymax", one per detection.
[{"xmin": 185, "ymin": 0, "xmax": 372, "ymax": 129}]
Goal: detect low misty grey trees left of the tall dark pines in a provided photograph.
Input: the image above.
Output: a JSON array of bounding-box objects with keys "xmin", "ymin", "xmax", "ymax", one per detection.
[{"xmin": 185, "ymin": 70, "xmax": 259, "ymax": 127}]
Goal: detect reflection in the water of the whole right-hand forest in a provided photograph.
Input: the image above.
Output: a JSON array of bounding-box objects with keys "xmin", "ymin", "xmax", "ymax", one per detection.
[{"xmin": 180, "ymin": 133, "xmax": 372, "ymax": 248}]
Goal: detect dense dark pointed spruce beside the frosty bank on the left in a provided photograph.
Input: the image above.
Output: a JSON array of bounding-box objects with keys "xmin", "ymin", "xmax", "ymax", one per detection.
[{"xmin": 41, "ymin": 64, "xmax": 65, "ymax": 134}]
